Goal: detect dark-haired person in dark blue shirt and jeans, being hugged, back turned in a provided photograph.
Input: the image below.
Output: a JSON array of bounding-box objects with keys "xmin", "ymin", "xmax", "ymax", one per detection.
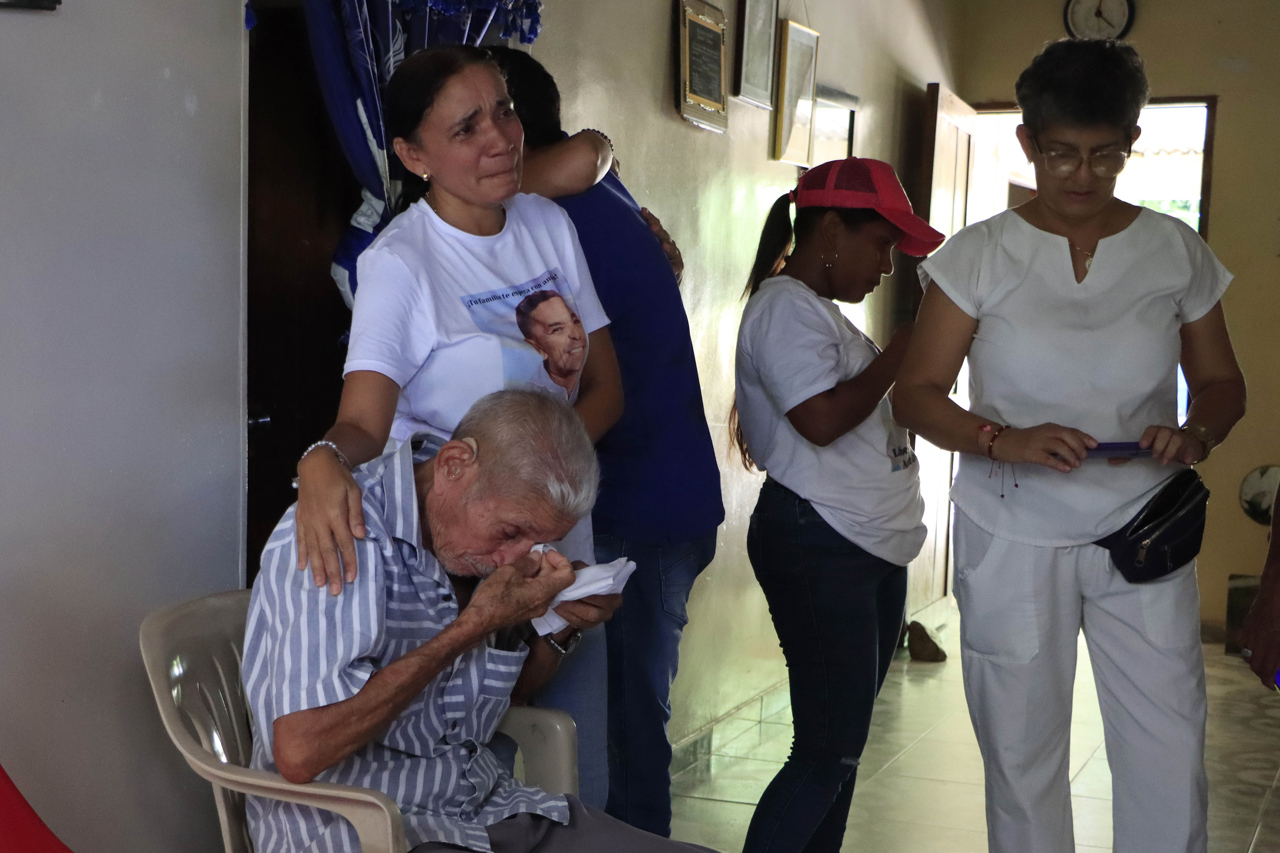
[{"xmin": 490, "ymin": 47, "xmax": 724, "ymax": 835}]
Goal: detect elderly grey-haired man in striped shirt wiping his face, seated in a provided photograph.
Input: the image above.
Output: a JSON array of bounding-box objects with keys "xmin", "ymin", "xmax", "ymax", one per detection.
[{"xmin": 243, "ymin": 391, "xmax": 701, "ymax": 853}]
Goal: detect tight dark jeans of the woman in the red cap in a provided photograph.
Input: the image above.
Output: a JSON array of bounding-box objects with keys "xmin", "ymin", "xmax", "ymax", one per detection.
[{"xmin": 742, "ymin": 480, "xmax": 906, "ymax": 853}]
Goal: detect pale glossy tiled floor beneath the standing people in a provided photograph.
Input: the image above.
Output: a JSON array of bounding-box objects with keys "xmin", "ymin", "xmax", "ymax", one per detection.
[{"xmin": 673, "ymin": 602, "xmax": 1280, "ymax": 853}]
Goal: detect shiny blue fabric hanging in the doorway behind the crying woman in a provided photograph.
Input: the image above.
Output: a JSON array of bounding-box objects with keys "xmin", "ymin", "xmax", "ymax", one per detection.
[{"xmin": 302, "ymin": 0, "xmax": 541, "ymax": 306}]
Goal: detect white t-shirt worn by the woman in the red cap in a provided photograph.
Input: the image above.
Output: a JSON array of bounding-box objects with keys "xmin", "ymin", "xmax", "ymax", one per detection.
[{"xmin": 737, "ymin": 275, "xmax": 925, "ymax": 566}]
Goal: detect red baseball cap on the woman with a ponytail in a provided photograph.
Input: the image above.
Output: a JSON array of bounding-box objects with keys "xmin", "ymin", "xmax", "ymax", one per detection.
[{"xmin": 791, "ymin": 158, "xmax": 946, "ymax": 257}]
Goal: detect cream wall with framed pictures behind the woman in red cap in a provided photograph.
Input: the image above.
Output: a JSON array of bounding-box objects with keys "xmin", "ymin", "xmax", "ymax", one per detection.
[{"xmin": 532, "ymin": 0, "xmax": 955, "ymax": 742}]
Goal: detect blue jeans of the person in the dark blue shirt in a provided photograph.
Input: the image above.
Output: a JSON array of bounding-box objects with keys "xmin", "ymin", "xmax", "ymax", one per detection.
[{"xmin": 595, "ymin": 530, "xmax": 716, "ymax": 836}]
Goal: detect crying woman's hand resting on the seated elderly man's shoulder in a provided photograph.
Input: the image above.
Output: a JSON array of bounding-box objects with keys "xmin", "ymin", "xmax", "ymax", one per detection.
[{"xmin": 294, "ymin": 448, "xmax": 365, "ymax": 596}]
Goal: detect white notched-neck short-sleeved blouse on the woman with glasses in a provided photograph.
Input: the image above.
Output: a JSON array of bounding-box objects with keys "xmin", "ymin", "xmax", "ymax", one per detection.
[{"xmin": 919, "ymin": 209, "xmax": 1231, "ymax": 547}]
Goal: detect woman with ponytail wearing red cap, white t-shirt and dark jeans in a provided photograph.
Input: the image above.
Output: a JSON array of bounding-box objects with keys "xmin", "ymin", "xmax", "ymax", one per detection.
[{"xmin": 735, "ymin": 158, "xmax": 942, "ymax": 853}]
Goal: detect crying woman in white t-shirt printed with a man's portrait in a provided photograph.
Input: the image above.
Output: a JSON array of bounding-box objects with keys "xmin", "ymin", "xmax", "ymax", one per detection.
[{"xmin": 297, "ymin": 46, "xmax": 622, "ymax": 808}]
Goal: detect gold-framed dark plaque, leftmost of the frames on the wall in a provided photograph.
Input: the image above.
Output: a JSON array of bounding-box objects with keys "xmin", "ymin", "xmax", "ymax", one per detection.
[{"xmin": 676, "ymin": 0, "xmax": 728, "ymax": 133}]
